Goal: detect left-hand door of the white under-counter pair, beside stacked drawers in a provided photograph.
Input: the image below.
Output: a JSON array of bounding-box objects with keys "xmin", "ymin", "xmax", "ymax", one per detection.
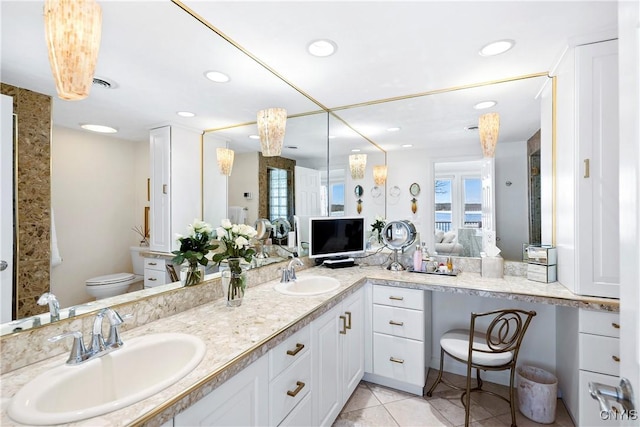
[{"xmin": 311, "ymin": 305, "xmax": 344, "ymax": 426}]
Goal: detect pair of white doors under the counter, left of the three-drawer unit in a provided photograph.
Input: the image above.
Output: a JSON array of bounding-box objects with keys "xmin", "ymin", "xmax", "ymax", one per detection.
[{"xmin": 311, "ymin": 288, "xmax": 365, "ymax": 426}]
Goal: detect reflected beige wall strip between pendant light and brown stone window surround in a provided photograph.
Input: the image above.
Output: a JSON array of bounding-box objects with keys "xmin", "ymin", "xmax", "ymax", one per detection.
[{"xmin": 228, "ymin": 151, "xmax": 260, "ymax": 226}]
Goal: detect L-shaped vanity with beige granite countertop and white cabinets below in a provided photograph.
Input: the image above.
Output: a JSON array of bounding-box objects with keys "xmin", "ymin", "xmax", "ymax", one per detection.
[{"xmin": 0, "ymin": 264, "xmax": 619, "ymax": 425}]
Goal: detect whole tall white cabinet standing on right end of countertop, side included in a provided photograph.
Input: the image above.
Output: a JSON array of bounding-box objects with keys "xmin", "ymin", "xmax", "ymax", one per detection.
[{"xmin": 556, "ymin": 40, "xmax": 621, "ymax": 298}]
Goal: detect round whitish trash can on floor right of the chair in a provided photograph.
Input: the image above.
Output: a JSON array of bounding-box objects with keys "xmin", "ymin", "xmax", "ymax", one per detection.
[{"xmin": 516, "ymin": 365, "xmax": 558, "ymax": 424}]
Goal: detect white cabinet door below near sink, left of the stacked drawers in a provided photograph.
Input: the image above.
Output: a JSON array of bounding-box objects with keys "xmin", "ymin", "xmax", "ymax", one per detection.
[{"xmin": 174, "ymin": 356, "xmax": 269, "ymax": 427}]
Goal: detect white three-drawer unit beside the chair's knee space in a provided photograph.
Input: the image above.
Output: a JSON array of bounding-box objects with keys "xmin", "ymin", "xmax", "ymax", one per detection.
[{"xmin": 364, "ymin": 285, "xmax": 431, "ymax": 396}]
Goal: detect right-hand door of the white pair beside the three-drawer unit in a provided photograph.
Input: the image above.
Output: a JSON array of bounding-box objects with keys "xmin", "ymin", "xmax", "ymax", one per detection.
[{"xmin": 341, "ymin": 291, "xmax": 364, "ymax": 401}]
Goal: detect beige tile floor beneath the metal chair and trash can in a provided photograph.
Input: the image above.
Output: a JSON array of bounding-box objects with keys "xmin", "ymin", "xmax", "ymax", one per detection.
[{"xmin": 333, "ymin": 369, "xmax": 574, "ymax": 427}]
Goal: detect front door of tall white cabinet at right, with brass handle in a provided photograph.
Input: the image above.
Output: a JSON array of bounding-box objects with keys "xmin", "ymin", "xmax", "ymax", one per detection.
[{"xmin": 576, "ymin": 40, "xmax": 620, "ymax": 298}]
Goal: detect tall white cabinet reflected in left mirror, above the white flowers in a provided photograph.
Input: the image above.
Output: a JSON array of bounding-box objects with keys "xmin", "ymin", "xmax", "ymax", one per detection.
[{"xmin": 149, "ymin": 126, "xmax": 202, "ymax": 252}]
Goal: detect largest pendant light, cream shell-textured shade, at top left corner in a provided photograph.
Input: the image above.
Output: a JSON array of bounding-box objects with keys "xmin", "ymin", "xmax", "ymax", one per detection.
[{"xmin": 44, "ymin": 0, "xmax": 102, "ymax": 101}]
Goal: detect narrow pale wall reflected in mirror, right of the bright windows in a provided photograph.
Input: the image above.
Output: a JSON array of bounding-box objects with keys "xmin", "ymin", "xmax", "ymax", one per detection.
[{"xmin": 495, "ymin": 141, "xmax": 529, "ymax": 260}]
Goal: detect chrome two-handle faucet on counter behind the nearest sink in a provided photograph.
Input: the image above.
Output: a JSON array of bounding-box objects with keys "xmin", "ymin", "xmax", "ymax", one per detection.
[{"xmin": 49, "ymin": 307, "xmax": 126, "ymax": 365}]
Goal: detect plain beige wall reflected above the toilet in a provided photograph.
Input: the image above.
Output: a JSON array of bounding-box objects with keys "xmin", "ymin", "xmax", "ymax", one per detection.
[{"xmin": 51, "ymin": 127, "xmax": 149, "ymax": 307}]
